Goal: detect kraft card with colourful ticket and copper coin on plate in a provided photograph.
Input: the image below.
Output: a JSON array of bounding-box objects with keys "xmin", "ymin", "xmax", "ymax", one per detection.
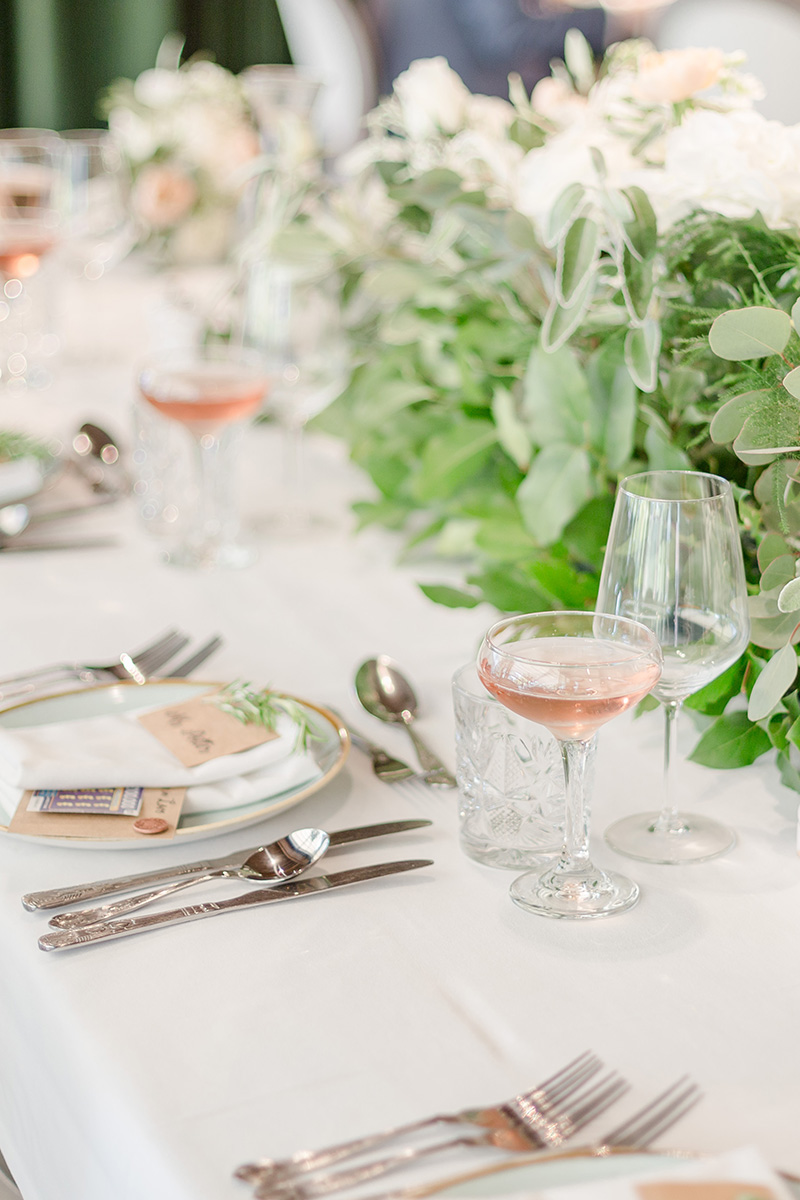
[{"xmin": 8, "ymin": 787, "xmax": 186, "ymax": 841}]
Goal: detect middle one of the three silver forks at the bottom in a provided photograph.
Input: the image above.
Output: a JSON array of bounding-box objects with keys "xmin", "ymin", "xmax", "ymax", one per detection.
[{"xmin": 255, "ymin": 1072, "xmax": 630, "ymax": 1200}]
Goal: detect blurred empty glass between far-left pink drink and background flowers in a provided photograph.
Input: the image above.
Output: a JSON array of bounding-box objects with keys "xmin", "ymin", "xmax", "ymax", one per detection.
[{"xmin": 60, "ymin": 130, "xmax": 137, "ymax": 280}]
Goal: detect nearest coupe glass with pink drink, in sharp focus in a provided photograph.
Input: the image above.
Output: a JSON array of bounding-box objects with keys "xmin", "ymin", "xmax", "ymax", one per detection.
[{"xmin": 477, "ymin": 612, "xmax": 661, "ymax": 919}]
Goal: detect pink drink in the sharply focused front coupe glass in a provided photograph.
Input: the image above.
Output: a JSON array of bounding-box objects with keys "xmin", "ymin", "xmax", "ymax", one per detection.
[{"xmin": 477, "ymin": 637, "xmax": 661, "ymax": 742}]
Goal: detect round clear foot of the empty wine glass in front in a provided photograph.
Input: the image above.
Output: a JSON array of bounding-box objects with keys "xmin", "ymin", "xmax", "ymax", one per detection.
[{"xmin": 604, "ymin": 812, "xmax": 736, "ymax": 865}]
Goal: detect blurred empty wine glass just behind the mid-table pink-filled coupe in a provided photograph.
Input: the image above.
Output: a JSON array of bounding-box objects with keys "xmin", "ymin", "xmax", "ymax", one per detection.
[{"xmin": 242, "ymin": 259, "xmax": 348, "ymax": 532}]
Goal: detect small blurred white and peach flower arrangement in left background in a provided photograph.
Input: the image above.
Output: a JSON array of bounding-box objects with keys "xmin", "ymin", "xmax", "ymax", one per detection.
[{"xmin": 104, "ymin": 59, "xmax": 260, "ymax": 263}]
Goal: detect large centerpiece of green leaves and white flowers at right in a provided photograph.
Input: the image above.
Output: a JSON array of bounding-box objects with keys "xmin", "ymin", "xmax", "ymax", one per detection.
[{"xmin": 281, "ymin": 35, "xmax": 800, "ymax": 790}]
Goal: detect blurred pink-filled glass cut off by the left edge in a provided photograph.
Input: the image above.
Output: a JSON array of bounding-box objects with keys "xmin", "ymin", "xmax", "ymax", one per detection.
[{"xmin": 0, "ymin": 131, "xmax": 66, "ymax": 389}]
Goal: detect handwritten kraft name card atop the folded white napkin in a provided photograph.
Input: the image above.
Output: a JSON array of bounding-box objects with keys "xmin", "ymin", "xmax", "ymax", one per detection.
[{"xmin": 137, "ymin": 694, "xmax": 277, "ymax": 767}]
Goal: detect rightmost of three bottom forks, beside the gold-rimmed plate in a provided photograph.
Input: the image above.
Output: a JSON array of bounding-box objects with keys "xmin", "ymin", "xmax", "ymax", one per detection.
[{"xmin": 352, "ymin": 1075, "xmax": 703, "ymax": 1200}]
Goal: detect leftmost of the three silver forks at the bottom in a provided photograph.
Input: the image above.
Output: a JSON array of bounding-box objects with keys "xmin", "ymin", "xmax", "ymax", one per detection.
[{"xmin": 235, "ymin": 1051, "xmax": 602, "ymax": 1184}]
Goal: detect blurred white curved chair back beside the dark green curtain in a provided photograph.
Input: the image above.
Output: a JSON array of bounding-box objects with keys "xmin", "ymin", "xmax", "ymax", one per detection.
[{"xmin": 277, "ymin": 0, "xmax": 378, "ymax": 155}]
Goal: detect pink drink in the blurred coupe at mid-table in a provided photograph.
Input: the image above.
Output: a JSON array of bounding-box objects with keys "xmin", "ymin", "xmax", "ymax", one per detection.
[{"xmin": 139, "ymin": 362, "xmax": 265, "ymax": 430}]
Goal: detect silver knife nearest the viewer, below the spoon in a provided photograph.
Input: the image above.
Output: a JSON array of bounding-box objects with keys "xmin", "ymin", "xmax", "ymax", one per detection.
[{"xmin": 38, "ymin": 858, "xmax": 433, "ymax": 950}]
